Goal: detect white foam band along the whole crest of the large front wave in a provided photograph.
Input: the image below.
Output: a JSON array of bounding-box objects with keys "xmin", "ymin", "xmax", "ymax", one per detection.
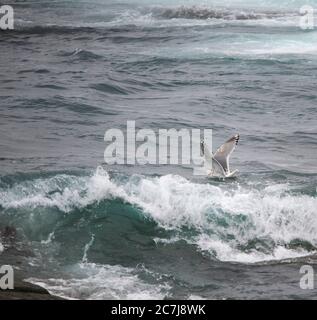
[{"xmin": 0, "ymin": 168, "xmax": 317, "ymax": 263}]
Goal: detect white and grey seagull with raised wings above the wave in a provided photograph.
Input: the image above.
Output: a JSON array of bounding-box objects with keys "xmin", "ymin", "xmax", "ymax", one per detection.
[{"xmin": 200, "ymin": 134, "xmax": 240, "ymax": 178}]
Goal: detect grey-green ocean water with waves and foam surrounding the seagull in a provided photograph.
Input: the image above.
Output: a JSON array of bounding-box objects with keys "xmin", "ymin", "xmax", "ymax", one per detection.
[{"xmin": 0, "ymin": 0, "xmax": 317, "ymax": 299}]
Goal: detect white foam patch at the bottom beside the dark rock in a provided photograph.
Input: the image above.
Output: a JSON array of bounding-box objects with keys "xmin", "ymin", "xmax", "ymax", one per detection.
[{"xmin": 26, "ymin": 263, "xmax": 170, "ymax": 300}]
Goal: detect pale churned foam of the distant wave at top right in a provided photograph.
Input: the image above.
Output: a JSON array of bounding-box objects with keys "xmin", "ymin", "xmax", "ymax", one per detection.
[{"xmin": 102, "ymin": 2, "xmax": 314, "ymax": 28}]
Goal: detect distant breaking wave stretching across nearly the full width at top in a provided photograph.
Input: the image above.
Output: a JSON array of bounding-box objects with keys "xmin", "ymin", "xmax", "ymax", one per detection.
[{"xmin": 11, "ymin": 5, "xmax": 301, "ymax": 31}]
